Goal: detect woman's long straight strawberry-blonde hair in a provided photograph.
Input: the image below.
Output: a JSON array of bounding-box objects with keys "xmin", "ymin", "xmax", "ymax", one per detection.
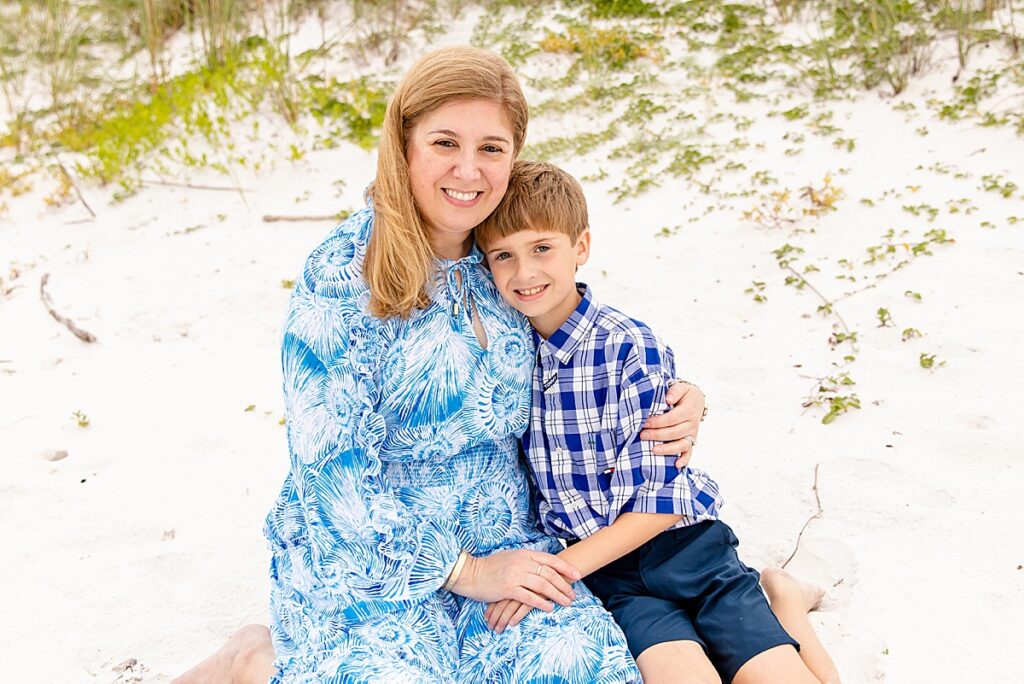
[{"xmin": 362, "ymin": 46, "xmax": 529, "ymax": 317}]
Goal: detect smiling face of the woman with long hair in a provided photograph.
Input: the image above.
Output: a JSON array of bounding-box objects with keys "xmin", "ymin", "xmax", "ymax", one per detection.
[{"xmin": 406, "ymin": 99, "xmax": 513, "ymax": 247}]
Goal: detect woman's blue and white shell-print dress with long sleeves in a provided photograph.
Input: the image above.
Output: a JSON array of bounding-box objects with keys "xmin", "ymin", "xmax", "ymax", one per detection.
[{"xmin": 264, "ymin": 208, "xmax": 640, "ymax": 684}]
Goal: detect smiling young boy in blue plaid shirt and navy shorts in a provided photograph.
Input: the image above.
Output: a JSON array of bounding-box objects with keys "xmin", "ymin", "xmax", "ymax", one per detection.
[{"xmin": 476, "ymin": 162, "xmax": 839, "ymax": 684}]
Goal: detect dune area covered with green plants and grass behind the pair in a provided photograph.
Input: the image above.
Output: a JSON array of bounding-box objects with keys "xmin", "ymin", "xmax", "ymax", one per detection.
[{"xmin": 0, "ymin": 0, "xmax": 1024, "ymax": 423}]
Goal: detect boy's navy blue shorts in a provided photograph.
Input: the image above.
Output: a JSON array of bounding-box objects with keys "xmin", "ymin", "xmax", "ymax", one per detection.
[{"xmin": 584, "ymin": 520, "xmax": 800, "ymax": 682}]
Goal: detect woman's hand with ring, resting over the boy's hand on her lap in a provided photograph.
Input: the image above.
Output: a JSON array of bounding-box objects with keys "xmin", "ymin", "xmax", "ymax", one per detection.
[{"xmin": 452, "ymin": 549, "xmax": 582, "ymax": 612}]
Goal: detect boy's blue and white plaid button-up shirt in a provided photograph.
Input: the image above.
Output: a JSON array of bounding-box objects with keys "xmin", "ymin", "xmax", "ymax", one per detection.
[{"xmin": 523, "ymin": 284, "xmax": 723, "ymax": 539}]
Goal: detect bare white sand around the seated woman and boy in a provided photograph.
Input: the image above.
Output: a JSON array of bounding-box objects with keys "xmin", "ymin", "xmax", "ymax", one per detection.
[{"xmin": 0, "ymin": 6, "xmax": 1024, "ymax": 683}]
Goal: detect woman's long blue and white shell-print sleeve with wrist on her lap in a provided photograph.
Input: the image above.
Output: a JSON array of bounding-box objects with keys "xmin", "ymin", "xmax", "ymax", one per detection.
[{"xmin": 267, "ymin": 208, "xmax": 459, "ymax": 610}]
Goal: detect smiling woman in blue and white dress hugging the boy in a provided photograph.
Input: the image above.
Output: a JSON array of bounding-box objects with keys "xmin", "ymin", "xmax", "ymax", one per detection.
[{"xmin": 180, "ymin": 47, "xmax": 703, "ymax": 683}]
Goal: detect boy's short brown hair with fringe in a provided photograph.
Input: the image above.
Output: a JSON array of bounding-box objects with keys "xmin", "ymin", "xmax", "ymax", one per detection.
[{"xmin": 475, "ymin": 162, "xmax": 590, "ymax": 250}]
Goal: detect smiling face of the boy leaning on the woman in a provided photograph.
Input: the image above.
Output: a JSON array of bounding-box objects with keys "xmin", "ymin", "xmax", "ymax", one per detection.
[{"xmin": 487, "ymin": 229, "xmax": 590, "ymax": 337}]
